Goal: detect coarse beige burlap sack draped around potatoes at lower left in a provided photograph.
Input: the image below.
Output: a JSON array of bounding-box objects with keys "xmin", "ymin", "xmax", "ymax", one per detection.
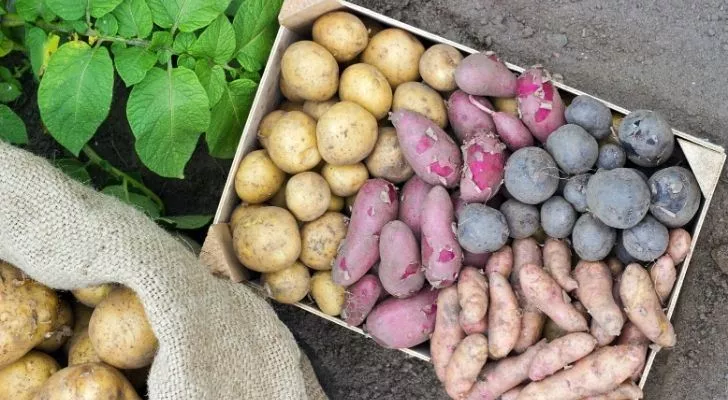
[{"xmin": 0, "ymin": 142, "xmax": 326, "ymax": 400}]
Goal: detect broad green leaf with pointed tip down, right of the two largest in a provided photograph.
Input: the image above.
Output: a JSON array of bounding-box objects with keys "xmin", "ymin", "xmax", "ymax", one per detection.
[{"xmin": 126, "ymin": 68, "xmax": 210, "ymax": 178}]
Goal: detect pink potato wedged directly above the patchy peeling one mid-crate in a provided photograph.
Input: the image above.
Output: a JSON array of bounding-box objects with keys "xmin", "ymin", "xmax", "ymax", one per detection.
[{"xmin": 447, "ymin": 90, "xmax": 495, "ymax": 143}]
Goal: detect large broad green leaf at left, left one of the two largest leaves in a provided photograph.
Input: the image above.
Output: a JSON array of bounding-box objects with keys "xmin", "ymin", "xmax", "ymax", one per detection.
[{"xmin": 38, "ymin": 41, "xmax": 114, "ymax": 156}]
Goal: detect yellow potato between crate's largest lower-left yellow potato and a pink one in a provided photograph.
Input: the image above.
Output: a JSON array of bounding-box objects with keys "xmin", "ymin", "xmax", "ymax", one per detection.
[{"xmin": 301, "ymin": 211, "xmax": 348, "ymax": 271}]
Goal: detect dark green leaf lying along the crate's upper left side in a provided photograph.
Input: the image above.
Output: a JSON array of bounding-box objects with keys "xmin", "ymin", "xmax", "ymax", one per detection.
[{"xmin": 205, "ymin": 79, "xmax": 258, "ymax": 158}]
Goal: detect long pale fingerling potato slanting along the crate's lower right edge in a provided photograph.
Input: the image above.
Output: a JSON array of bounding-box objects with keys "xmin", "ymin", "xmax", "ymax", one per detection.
[{"xmin": 619, "ymin": 264, "xmax": 677, "ymax": 347}]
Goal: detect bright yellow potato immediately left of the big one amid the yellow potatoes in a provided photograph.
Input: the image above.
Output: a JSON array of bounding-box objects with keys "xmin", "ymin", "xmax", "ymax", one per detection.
[{"xmin": 268, "ymin": 111, "xmax": 321, "ymax": 174}]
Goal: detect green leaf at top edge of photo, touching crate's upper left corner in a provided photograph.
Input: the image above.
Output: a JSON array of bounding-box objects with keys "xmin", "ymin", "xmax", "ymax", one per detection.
[{"xmin": 233, "ymin": 0, "xmax": 283, "ymax": 71}]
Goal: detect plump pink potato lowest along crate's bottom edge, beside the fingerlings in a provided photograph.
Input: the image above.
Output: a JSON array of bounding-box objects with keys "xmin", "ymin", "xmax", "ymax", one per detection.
[{"xmin": 364, "ymin": 288, "xmax": 437, "ymax": 349}]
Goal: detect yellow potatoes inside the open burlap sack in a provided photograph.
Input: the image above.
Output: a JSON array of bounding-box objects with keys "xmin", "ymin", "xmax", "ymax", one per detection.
[{"xmin": 0, "ymin": 261, "xmax": 158, "ymax": 400}]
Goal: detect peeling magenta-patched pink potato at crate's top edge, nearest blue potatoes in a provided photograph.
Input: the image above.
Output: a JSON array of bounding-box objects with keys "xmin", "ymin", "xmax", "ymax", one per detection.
[{"xmin": 516, "ymin": 65, "xmax": 566, "ymax": 143}]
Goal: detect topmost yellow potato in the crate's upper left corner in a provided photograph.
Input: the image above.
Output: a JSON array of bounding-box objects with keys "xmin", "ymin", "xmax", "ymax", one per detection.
[{"xmin": 311, "ymin": 11, "xmax": 369, "ymax": 62}]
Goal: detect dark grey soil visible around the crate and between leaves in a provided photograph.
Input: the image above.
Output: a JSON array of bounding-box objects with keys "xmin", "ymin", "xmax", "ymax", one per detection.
[{"xmin": 9, "ymin": 0, "xmax": 728, "ymax": 400}]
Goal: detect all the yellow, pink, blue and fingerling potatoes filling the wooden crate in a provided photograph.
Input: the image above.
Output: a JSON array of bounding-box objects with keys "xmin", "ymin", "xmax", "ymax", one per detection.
[{"xmin": 230, "ymin": 12, "xmax": 702, "ymax": 400}]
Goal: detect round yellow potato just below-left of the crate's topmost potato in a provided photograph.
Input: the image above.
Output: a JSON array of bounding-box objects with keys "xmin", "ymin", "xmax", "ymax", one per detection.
[{"xmin": 281, "ymin": 40, "xmax": 339, "ymax": 101}]
